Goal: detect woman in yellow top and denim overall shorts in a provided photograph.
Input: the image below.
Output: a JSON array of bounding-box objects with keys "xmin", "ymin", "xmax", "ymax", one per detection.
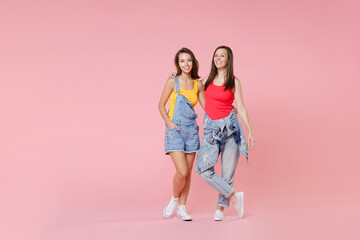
[{"xmin": 159, "ymin": 48, "xmax": 205, "ymax": 221}]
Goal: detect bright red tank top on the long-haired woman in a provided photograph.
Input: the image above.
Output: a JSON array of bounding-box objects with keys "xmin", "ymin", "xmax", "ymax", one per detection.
[{"xmin": 205, "ymin": 83, "xmax": 234, "ymax": 120}]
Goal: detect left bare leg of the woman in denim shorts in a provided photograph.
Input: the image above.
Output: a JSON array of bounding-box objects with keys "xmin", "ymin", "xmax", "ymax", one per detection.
[{"xmin": 170, "ymin": 152, "xmax": 188, "ymax": 198}]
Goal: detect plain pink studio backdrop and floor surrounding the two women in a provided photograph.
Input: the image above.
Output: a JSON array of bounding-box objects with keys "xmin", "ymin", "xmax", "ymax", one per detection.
[{"xmin": 0, "ymin": 0, "xmax": 360, "ymax": 240}]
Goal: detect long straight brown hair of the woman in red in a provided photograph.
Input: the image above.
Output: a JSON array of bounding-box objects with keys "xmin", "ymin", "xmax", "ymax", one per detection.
[{"xmin": 205, "ymin": 46, "xmax": 235, "ymax": 91}]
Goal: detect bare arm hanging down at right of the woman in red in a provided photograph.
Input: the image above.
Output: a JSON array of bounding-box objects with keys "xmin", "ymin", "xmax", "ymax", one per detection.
[{"xmin": 234, "ymin": 78, "xmax": 255, "ymax": 149}]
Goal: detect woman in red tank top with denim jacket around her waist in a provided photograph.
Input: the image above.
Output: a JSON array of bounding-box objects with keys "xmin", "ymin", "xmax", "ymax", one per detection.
[{"xmin": 196, "ymin": 46, "xmax": 255, "ymax": 221}]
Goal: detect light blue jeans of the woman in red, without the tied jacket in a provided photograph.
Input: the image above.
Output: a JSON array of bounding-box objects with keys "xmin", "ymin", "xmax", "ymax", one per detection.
[{"xmin": 200, "ymin": 133, "xmax": 240, "ymax": 207}]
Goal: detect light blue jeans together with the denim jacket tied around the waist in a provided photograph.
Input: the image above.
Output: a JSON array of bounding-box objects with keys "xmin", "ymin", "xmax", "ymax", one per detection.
[{"xmin": 196, "ymin": 111, "xmax": 247, "ymax": 207}]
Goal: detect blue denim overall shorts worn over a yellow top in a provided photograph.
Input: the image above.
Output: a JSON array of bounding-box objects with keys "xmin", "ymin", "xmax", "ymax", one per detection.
[{"xmin": 165, "ymin": 76, "xmax": 200, "ymax": 154}]
